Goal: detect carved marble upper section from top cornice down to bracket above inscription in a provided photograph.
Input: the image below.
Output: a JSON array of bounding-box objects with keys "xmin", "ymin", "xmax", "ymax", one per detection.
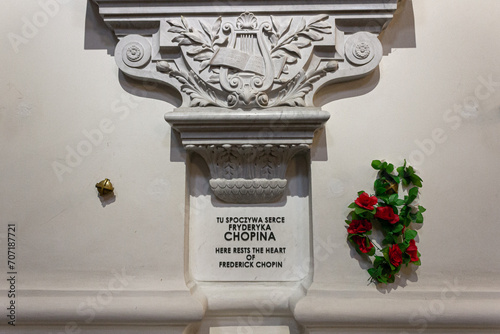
[{"xmin": 94, "ymin": 0, "xmax": 397, "ymax": 203}]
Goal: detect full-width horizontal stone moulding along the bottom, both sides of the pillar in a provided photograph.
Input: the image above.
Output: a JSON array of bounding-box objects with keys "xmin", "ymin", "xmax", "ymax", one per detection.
[{"xmin": 10, "ymin": 286, "xmax": 500, "ymax": 334}]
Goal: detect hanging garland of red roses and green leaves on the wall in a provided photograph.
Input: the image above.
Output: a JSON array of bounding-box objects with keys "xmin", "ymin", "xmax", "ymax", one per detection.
[{"xmin": 346, "ymin": 160, "xmax": 425, "ymax": 283}]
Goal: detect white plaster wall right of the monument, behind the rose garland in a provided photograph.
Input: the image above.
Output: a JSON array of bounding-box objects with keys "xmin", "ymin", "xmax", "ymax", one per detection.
[{"xmin": 312, "ymin": 1, "xmax": 500, "ymax": 291}]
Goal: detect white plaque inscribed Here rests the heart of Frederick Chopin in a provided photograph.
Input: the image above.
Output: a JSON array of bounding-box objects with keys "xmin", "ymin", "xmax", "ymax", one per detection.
[{"xmin": 189, "ymin": 155, "xmax": 310, "ymax": 281}]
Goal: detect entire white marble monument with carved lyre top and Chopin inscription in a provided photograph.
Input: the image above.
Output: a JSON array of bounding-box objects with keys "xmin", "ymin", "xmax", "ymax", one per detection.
[{"xmin": 94, "ymin": 0, "xmax": 397, "ymax": 332}]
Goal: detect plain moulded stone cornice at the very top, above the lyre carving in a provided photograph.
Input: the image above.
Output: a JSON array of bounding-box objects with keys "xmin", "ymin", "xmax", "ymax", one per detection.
[{"xmin": 94, "ymin": 0, "xmax": 398, "ymax": 36}]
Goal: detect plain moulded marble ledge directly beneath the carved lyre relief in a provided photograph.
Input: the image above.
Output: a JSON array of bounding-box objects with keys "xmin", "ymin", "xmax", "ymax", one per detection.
[{"xmin": 165, "ymin": 107, "xmax": 330, "ymax": 145}]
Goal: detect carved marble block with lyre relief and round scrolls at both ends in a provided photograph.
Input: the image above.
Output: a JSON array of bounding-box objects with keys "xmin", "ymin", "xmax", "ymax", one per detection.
[{"xmin": 107, "ymin": 6, "xmax": 392, "ymax": 109}]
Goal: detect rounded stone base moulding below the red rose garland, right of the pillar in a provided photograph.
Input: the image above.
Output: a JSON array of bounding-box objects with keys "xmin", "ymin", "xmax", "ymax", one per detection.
[{"xmin": 294, "ymin": 289, "xmax": 500, "ymax": 333}]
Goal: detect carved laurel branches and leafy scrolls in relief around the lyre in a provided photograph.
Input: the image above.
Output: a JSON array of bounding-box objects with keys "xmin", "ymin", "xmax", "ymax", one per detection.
[{"xmin": 157, "ymin": 12, "xmax": 337, "ymax": 108}]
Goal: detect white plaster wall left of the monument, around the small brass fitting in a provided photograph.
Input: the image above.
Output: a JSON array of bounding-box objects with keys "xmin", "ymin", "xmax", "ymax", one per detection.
[{"xmin": 0, "ymin": 0, "xmax": 188, "ymax": 290}]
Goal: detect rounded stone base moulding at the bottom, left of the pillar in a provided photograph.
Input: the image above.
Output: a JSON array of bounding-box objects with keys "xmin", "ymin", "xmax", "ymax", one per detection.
[{"xmin": 9, "ymin": 290, "xmax": 204, "ymax": 326}]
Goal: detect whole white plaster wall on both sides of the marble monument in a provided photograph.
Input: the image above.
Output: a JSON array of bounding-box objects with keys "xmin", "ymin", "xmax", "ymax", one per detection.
[{"xmin": 0, "ymin": 0, "xmax": 500, "ymax": 330}]
